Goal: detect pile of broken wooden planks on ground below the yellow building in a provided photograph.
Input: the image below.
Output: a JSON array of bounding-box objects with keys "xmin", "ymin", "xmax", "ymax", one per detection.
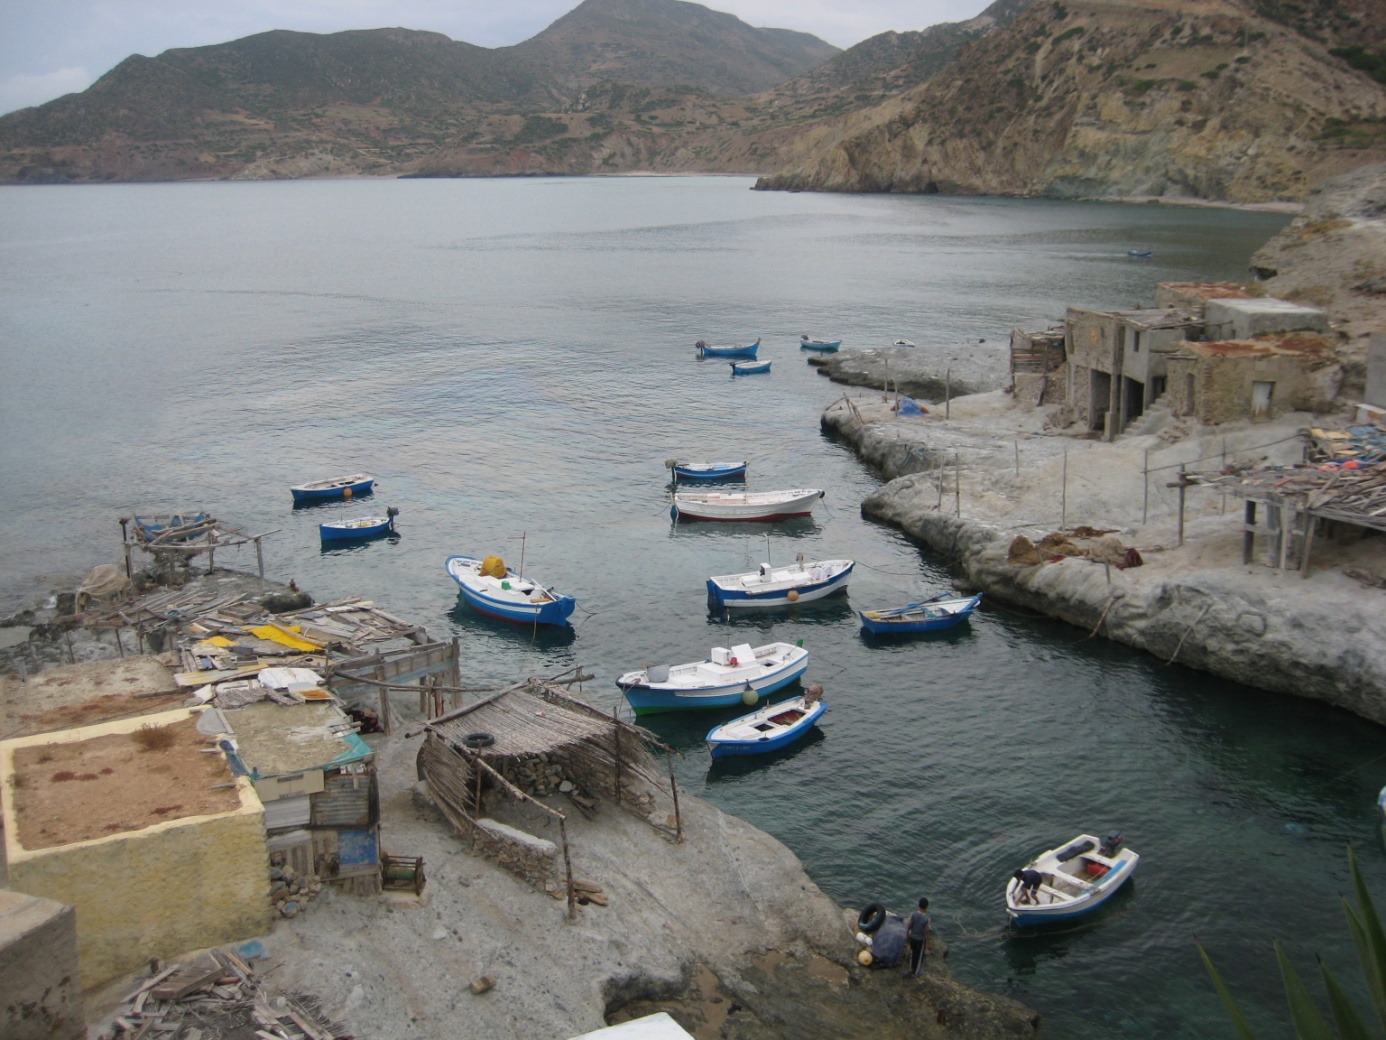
[{"xmin": 98, "ymin": 950, "xmax": 352, "ymax": 1040}]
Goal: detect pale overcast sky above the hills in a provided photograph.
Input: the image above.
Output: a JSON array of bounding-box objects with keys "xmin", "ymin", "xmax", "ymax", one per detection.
[{"xmin": 0, "ymin": 0, "xmax": 990, "ymax": 114}]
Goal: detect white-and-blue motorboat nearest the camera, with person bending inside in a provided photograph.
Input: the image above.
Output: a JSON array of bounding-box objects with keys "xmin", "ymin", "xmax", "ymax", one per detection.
[{"xmin": 1006, "ymin": 833, "xmax": 1141, "ymax": 928}]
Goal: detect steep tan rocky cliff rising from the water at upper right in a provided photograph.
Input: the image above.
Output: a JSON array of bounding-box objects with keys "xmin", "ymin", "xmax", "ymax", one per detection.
[{"xmin": 758, "ymin": 0, "xmax": 1386, "ymax": 202}]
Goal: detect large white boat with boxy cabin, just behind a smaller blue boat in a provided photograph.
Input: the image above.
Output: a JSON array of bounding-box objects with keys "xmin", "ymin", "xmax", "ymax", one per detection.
[{"xmin": 615, "ymin": 642, "xmax": 808, "ymax": 716}]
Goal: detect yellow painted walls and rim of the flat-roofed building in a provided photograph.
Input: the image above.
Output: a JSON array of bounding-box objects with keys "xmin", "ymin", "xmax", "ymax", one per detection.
[{"xmin": 0, "ymin": 709, "xmax": 269, "ymax": 989}]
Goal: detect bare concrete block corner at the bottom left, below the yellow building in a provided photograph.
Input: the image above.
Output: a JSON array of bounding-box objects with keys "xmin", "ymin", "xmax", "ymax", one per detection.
[{"xmin": 0, "ymin": 889, "xmax": 86, "ymax": 1040}]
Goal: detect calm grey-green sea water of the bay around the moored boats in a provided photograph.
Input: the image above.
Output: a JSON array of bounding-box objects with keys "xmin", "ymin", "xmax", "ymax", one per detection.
[{"xmin": 0, "ymin": 179, "xmax": 1386, "ymax": 1039}]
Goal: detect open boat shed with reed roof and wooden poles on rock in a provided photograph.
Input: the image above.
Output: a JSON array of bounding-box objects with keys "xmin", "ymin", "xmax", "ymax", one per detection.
[{"xmin": 419, "ymin": 679, "xmax": 682, "ymax": 914}]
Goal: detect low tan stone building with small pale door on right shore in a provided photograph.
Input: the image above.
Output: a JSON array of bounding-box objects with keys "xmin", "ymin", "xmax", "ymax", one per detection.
[{"xmin": 1167, "ymin": 333, "xmax": 1343, "ymax": 424}]
